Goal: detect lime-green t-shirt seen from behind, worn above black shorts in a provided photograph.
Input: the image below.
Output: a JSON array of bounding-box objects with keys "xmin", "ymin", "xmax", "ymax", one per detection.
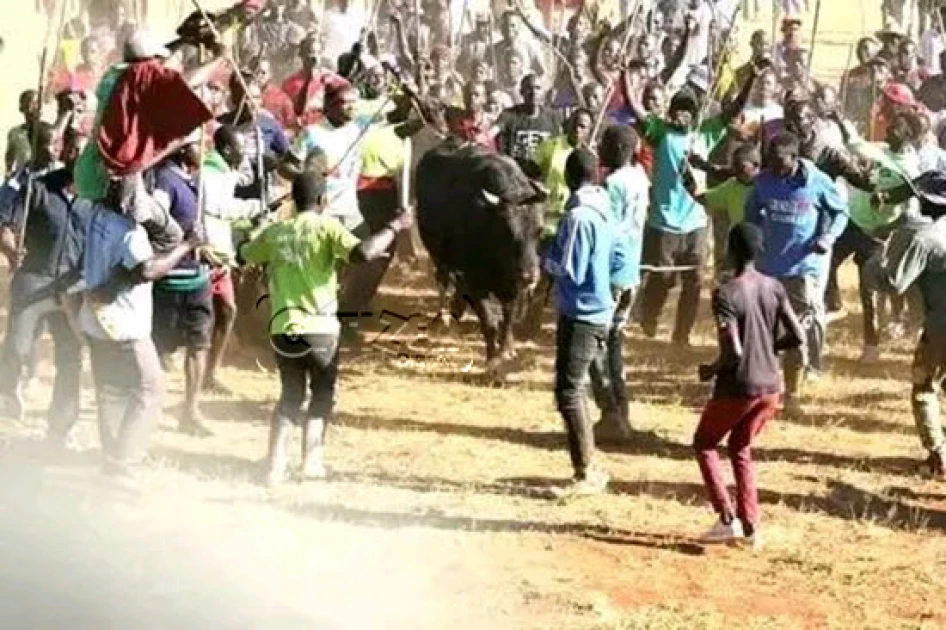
[{"xmin": 241, "ymin": 212, "xmax": 359, "ymax": 335}]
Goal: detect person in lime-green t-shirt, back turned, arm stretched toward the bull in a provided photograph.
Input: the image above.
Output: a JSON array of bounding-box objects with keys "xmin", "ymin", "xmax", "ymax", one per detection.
[{"xmin": 239, "ymin": 171, "xmax": 411, "ymax": 484}]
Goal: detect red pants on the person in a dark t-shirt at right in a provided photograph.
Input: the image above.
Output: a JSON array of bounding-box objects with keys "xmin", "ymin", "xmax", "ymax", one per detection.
[{"xmin": 693, "ymin": 394, "xmax": 780, "ymax": 525}]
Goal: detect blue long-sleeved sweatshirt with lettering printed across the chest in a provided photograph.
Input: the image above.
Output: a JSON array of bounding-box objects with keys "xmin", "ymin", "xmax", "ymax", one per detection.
[{"xmin": 746, "ymin": 160, "xmax": 847, "ymax": 278}]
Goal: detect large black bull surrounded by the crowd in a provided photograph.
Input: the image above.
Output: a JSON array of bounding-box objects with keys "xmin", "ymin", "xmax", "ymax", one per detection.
[{"xmin": 415, "ymin": 140, "xmax": 547, "ymax": 367}]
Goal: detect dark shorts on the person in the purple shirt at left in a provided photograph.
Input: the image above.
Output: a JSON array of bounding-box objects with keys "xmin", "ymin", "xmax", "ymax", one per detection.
[{"xmin": 152, "ymin": 282, "xmax": 214, "ymax": 354}]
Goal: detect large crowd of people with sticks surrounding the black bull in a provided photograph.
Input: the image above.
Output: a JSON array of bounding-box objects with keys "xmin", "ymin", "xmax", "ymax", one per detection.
[{"xmin": 0, "ymin": 0, "xmax": 946, "ymax": 544}]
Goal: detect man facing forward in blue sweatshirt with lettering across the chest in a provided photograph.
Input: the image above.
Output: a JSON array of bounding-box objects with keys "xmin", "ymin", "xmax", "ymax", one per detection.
[{"xmin": 746, "ymin": 132, "xmax": 847, "ymax": 413}]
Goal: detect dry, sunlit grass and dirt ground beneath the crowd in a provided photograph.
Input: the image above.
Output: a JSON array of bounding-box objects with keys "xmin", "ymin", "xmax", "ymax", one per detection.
[{"xmin": 0, "ymin": 0, "xmax": 946, "ymax": 630}]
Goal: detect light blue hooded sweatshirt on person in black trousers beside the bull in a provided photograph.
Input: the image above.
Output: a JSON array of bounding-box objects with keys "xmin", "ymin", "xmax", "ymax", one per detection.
[{"xmin": 544, "ymin": 186, "xmax": 623, "ymax": 325}]
